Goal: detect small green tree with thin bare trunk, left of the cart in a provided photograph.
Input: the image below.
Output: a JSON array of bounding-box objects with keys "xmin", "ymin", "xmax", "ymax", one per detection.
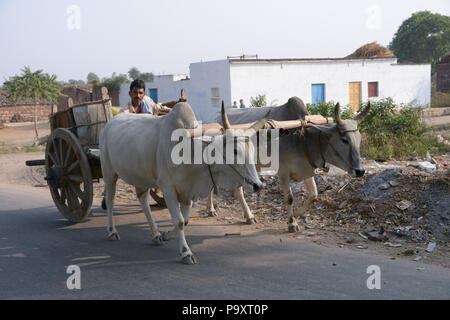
[{"xmin": 3, "ymin": 67, "xmax": 63, "ymax": 141}]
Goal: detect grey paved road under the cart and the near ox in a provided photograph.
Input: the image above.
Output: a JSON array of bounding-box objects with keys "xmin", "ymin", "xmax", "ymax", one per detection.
[{"xmin": 0, "ymin": 184, "xmax": 450, "ymax": 300}]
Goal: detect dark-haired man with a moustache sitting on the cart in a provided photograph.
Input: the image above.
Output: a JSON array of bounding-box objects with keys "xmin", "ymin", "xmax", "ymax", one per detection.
[{"xmin": 126, "ymin": 79, "xmax": 187, "ymax": 115}]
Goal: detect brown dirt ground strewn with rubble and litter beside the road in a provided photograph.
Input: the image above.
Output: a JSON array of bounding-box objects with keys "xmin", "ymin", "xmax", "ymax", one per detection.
[{"xmin": 0, "ymin": 124, "xmax": 450, "ymax": 267}]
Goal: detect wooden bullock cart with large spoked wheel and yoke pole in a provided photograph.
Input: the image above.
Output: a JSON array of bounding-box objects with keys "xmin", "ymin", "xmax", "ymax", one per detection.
[{"xmin": 26, "ymin": 99, "xmax": 332, "ymax": 222}]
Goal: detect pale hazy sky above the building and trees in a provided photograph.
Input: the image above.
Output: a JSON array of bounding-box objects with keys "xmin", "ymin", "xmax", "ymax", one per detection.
[{"xmin": 0, "ymin": 0, "xmax": 450, "ymax": 84}]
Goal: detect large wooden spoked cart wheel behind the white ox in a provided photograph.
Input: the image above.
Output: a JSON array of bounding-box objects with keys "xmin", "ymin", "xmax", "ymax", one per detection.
[{"xmin": 45, "ymin": 128, "xmax": 93, "ymax": 222}]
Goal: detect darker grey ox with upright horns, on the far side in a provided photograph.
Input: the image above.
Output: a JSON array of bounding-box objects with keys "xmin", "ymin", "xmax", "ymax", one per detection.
[{"xmin": 207, "ymin": 97, "xmax": 370, "ymax": 232}]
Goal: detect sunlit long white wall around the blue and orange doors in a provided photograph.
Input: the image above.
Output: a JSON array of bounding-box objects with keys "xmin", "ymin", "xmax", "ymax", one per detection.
[{"xmin": 230, "ymin": 59, "xmax": 431, "ymax": 110}]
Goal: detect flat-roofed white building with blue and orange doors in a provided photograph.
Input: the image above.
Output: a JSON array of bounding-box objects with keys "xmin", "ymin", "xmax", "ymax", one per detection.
[{"xmin": 119, "ymin": 58, "xmax": 431, "ymax": 122}]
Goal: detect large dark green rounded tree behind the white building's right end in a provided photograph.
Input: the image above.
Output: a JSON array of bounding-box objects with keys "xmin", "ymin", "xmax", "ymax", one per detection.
[{"xmin": 389, "ymin": 11, "xmax": 450, "ymax": 70}]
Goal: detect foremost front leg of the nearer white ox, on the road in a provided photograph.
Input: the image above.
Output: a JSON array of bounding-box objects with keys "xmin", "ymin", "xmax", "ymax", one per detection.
[{"xmin": 163, "ymin": 190, "xmax": 197, "ymax": 264}]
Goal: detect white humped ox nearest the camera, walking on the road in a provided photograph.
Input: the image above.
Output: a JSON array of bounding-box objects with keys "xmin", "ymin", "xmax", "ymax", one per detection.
[{"xmin": 100, "ymin": 103, "xmax": 266, "ymax": 264}]
